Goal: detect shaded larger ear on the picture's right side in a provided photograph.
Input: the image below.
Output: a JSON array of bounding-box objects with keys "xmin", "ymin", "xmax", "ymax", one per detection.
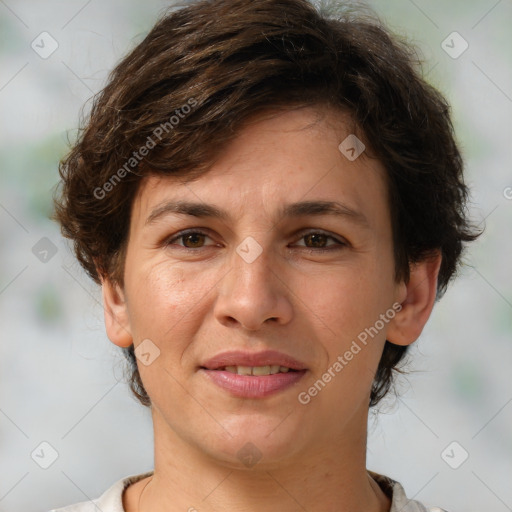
[{"xmin": 386, "ymin": 250, "xmax": 442, "ymax": 345}]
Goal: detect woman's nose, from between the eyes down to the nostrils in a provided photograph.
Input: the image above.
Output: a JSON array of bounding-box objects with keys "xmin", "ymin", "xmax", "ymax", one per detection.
[{"xmin": 214, "ymin": 245, "xmax": 293, "ymax": 331}]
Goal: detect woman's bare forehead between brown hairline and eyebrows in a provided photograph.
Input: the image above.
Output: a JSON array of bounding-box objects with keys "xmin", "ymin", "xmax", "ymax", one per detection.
[{"xmin": 132, "ymin": 107, "xmax": 388, "ymax": 228}]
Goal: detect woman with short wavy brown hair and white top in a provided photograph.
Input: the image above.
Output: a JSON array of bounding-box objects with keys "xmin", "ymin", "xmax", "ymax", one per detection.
[{"xmin": 49, "ymin": 0, "xmax": 478, "ymax": 512}]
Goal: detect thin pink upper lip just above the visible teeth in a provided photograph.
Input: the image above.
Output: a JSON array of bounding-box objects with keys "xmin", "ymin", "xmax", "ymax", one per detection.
[{"xmin": 202, "ymin": 350, "xmax": 306, "ymax": 370}]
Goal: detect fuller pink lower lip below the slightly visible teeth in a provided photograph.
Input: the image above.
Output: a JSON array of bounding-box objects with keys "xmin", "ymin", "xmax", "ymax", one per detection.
[{"xmin": 200, "ymin": 368, "xmax": 307, "ymax": 398}]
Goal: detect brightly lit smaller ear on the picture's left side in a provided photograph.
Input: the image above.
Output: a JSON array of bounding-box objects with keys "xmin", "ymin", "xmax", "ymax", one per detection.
[{"xmin": 101, "ymin": 279, "xmax": 133, "ymax": 347}]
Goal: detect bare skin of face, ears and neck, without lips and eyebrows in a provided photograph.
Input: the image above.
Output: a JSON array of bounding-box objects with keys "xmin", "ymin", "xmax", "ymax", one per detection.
[{"xmin": 103, "ymin": 106, "xmax": 441, "ymax": 512}]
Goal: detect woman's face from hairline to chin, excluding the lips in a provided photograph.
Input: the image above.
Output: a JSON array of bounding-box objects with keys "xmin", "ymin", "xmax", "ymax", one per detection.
[{"xmin": 105, "ymin": 109, "xmax": 412, "ymax": 465}]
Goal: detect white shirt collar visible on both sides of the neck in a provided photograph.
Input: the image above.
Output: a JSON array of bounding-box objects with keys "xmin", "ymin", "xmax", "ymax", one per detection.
[{"xmin": 50, "ymin": 471, "xmax": 446, "ymax": 512}]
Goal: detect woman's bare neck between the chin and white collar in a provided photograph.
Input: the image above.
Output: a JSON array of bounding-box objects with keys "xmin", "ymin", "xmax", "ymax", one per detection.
[{"xmin": 125, "ymin": 402, "xmax": 391, "ymax": 512}]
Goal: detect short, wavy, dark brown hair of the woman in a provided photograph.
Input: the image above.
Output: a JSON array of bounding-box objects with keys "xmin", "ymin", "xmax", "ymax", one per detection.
[{"xmin": 53, "ymin": 0, "xmax": 481, "ymax": 407}]
